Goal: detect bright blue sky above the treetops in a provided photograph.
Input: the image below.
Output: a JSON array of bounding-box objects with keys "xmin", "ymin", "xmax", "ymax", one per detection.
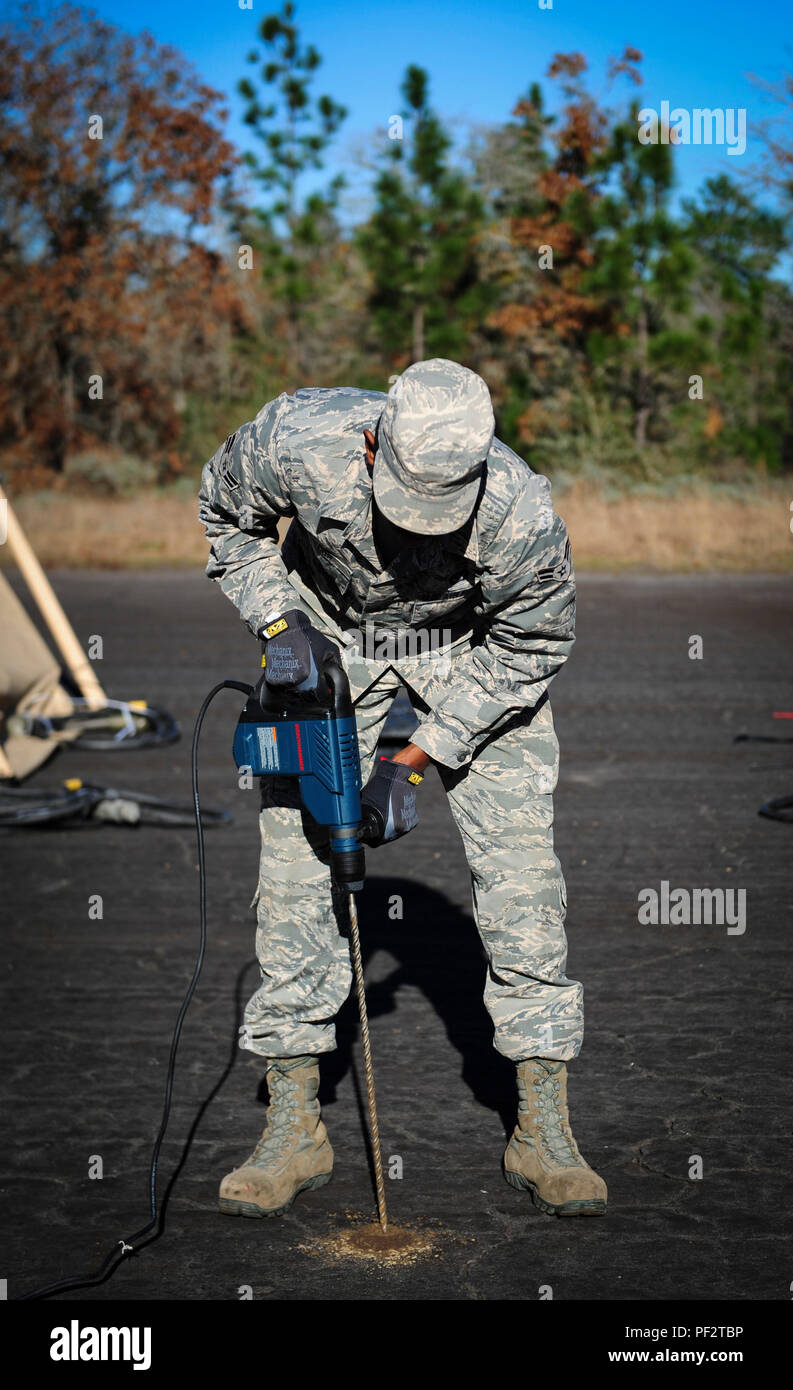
[{"xmin": 18, "ymin": 0, "xmax": 793, "ymax": 214}]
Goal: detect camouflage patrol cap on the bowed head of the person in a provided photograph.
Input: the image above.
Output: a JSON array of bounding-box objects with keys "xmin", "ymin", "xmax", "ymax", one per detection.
[{"xmin": 372, "ymin": 357, "xmax": 496, "ymax": 535}]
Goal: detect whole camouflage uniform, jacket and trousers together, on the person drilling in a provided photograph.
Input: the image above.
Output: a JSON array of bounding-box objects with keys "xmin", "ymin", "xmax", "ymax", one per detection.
[{"xmin": 200, "ymin": 364, "xmax": 582, "ymax": 1061}]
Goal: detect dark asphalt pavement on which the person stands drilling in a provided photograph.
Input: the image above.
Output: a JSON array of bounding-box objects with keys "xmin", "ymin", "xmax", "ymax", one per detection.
[{"xmin": 0, "ymin": 573, "xmax": 793, "ymax": 1301}]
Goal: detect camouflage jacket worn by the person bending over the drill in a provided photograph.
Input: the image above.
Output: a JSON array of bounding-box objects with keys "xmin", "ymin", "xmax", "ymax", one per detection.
[{"xmin": 199, "ymin": 386, "xmax": 575, "ymax": 767}]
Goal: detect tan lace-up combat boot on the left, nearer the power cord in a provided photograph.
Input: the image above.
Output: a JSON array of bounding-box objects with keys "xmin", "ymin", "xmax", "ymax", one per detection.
[{"xmin": 221, "ymin": 1056, "xmax": 333, "ymax": 1216}]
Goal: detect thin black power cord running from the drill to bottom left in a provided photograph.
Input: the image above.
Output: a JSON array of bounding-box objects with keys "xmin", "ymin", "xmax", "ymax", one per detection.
[{"xmin": 15, "ymin": 681, "xmax": 253, "ymax": 1302}]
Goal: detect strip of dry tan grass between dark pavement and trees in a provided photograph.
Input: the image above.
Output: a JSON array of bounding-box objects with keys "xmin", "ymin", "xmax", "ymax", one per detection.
[{"xmin": 0, "ymin": 482, "xmax": 793, "ymax": 573}]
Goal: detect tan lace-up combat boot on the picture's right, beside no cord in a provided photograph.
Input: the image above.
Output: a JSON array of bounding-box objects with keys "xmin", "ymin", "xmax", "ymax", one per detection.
[{"xmin": 504, "ymin": 1056, "xmax": 608, "ymax": 1216}]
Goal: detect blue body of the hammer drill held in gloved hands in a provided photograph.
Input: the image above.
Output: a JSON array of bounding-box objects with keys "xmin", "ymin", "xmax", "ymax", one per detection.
[{"xmin": 233, "ymin": 667, "xmax": 364, "ymax": 891}]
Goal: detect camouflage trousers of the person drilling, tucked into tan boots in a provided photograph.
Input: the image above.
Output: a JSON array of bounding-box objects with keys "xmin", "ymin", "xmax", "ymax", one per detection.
[{"xmin": 240, "ymin": 596, "xmax": 583, "ymax": 1062}]
